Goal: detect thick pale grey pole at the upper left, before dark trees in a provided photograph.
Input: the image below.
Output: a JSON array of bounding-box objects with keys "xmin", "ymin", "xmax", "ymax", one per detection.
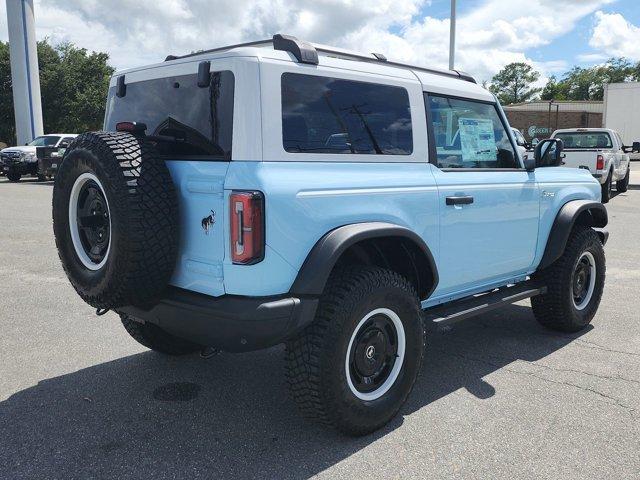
[{"xmin": 7, "ymin": 0, "xmax": 43, "ymax": 145}]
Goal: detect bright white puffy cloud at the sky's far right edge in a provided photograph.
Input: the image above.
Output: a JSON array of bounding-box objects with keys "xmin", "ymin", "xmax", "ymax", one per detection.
[{"xmin": 589, "ymin": 11, "xmax": 640, "ymax": 60}]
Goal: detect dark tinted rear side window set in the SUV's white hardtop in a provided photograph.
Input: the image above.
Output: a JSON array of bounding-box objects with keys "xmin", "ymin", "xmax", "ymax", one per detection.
[{"xmin": 282, "ymin": 73, "xmax": 413, "ymax": 155}]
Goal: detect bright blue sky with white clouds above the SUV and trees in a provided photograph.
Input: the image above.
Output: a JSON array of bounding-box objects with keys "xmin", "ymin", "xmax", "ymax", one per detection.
[{"xmin": 0, "ymin": 0, "xmax": 640, "ymax": 84}]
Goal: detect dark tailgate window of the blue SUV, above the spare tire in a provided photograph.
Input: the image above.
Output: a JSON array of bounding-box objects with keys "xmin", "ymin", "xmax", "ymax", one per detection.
[{"xmin": 105, "ymin": 71, "xmax": 234, "ymax": 160}]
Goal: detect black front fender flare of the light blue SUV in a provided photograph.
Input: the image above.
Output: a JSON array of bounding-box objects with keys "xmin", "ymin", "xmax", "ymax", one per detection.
[{"xmin": 538, "ymin": 200, "xmax": 609, "ymax": 270}]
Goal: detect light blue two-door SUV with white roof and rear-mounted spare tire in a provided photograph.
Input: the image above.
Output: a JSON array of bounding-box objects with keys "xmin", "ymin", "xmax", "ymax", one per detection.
[{"xmin": 53, "ymin": 35, "xmax": 607, "ymax": 435}]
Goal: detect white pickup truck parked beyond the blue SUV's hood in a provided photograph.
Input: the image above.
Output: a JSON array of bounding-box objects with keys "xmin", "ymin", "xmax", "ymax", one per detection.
[{"xmin": 551, "ymin": 128, "xmax": 633, "ymax": 203}]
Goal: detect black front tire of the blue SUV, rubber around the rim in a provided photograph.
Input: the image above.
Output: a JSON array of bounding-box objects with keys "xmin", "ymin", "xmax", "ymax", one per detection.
[{"xmin": 531, "ymin": 225, "xmax": 606, "ymax": 332}]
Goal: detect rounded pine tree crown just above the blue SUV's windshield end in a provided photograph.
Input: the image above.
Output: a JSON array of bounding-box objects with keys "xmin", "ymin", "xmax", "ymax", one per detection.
[{"xmin": 489, "ymin": 62, "xmax": 540, "ymax": 105}]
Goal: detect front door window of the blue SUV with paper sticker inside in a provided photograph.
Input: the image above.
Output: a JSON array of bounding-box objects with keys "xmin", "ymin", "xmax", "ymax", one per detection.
[{"xmin": 425, "ymin": 95, "xmax": 520, "ymax": 168}]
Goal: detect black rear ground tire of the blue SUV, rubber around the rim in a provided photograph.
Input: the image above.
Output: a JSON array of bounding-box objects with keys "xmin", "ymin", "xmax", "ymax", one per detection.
[{"xmin": 286, "ymin": 267, "xmax": 425, "ymax": 435}]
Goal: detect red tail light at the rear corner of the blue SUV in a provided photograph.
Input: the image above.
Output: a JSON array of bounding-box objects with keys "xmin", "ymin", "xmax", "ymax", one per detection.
[{"xmin": 229, "ymin": 191, "xmax": 264, "ymax": 265}]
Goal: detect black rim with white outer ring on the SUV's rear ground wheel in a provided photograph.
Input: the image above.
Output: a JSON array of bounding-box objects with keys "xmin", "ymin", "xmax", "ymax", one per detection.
[{"xmin": 349, "ymin": 314, "xmax": 398, "ymax": 393}]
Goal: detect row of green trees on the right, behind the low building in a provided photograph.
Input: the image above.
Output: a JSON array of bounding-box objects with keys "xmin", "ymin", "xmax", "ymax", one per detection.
[{"xmin": 484, "ymin": 58, "xmax": 640, "ymax": 105}]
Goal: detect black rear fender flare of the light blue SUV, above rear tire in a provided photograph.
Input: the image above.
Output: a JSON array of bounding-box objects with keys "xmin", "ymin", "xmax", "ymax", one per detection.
[{"xmin": 290, "ymin": 222, "xmax": 438, "ymax": 298}]
